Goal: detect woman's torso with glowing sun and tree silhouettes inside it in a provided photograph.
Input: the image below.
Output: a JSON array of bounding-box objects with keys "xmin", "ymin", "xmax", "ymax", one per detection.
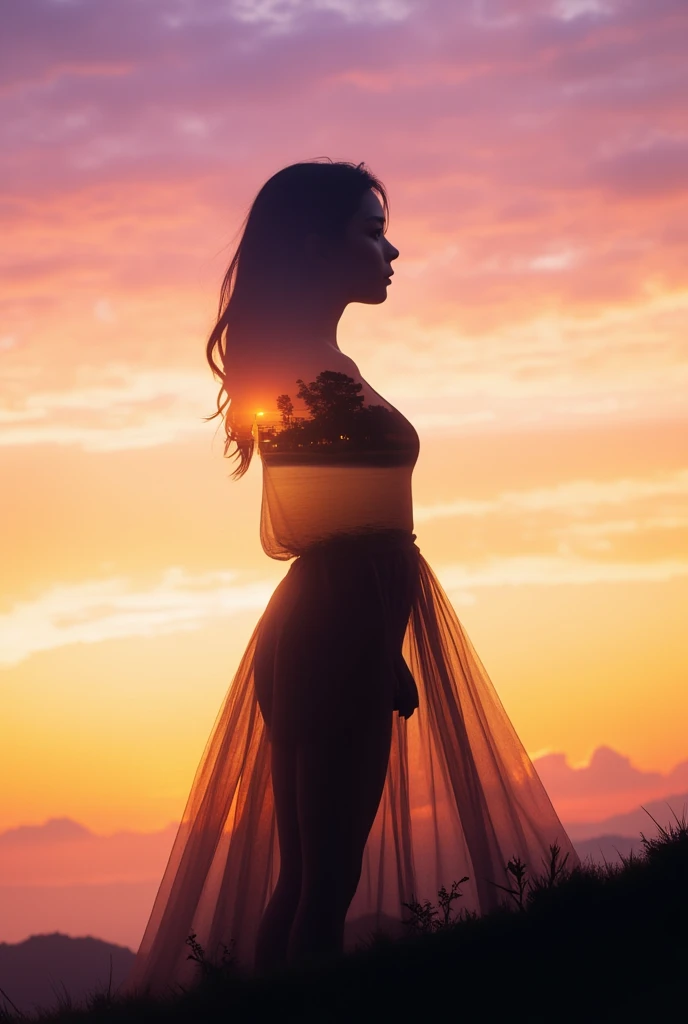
[{"xmin": 229, "ymin": 347, "xmax": 420, "ymax": 559}]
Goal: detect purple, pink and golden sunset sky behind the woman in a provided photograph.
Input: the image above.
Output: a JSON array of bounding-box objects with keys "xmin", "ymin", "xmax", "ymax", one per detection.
[{"xmin": 0, "ymin": 0, "xmax": 688, "ymax": 834}]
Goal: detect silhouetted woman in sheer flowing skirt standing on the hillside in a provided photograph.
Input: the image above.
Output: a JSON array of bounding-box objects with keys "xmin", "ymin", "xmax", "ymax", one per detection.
[{"xmin": 127, "ymin": 161, "xmax": 579, "ymax": 991}]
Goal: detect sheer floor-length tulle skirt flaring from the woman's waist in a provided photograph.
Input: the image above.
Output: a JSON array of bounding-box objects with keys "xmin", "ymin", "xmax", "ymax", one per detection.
[{"xmin": 124, "ymin": 530, "xmax": 579, "ymax": 993}]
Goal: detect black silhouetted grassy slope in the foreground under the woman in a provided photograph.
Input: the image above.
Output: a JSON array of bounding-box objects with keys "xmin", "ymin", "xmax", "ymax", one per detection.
[{"xmin": 0, "ymin": 819, "xmax": 688, "ymax": 1024}]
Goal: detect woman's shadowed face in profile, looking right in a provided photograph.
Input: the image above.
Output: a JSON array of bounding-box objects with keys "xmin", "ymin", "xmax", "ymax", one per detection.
[{"xmin": 315, "ymin": 189, "xmax": 399, "ymax": 303}]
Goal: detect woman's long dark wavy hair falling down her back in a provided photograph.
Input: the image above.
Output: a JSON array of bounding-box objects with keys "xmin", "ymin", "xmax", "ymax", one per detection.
[{"xmin": 206, "ymin": 158, "xmax": 389, "ymax": 480}]
